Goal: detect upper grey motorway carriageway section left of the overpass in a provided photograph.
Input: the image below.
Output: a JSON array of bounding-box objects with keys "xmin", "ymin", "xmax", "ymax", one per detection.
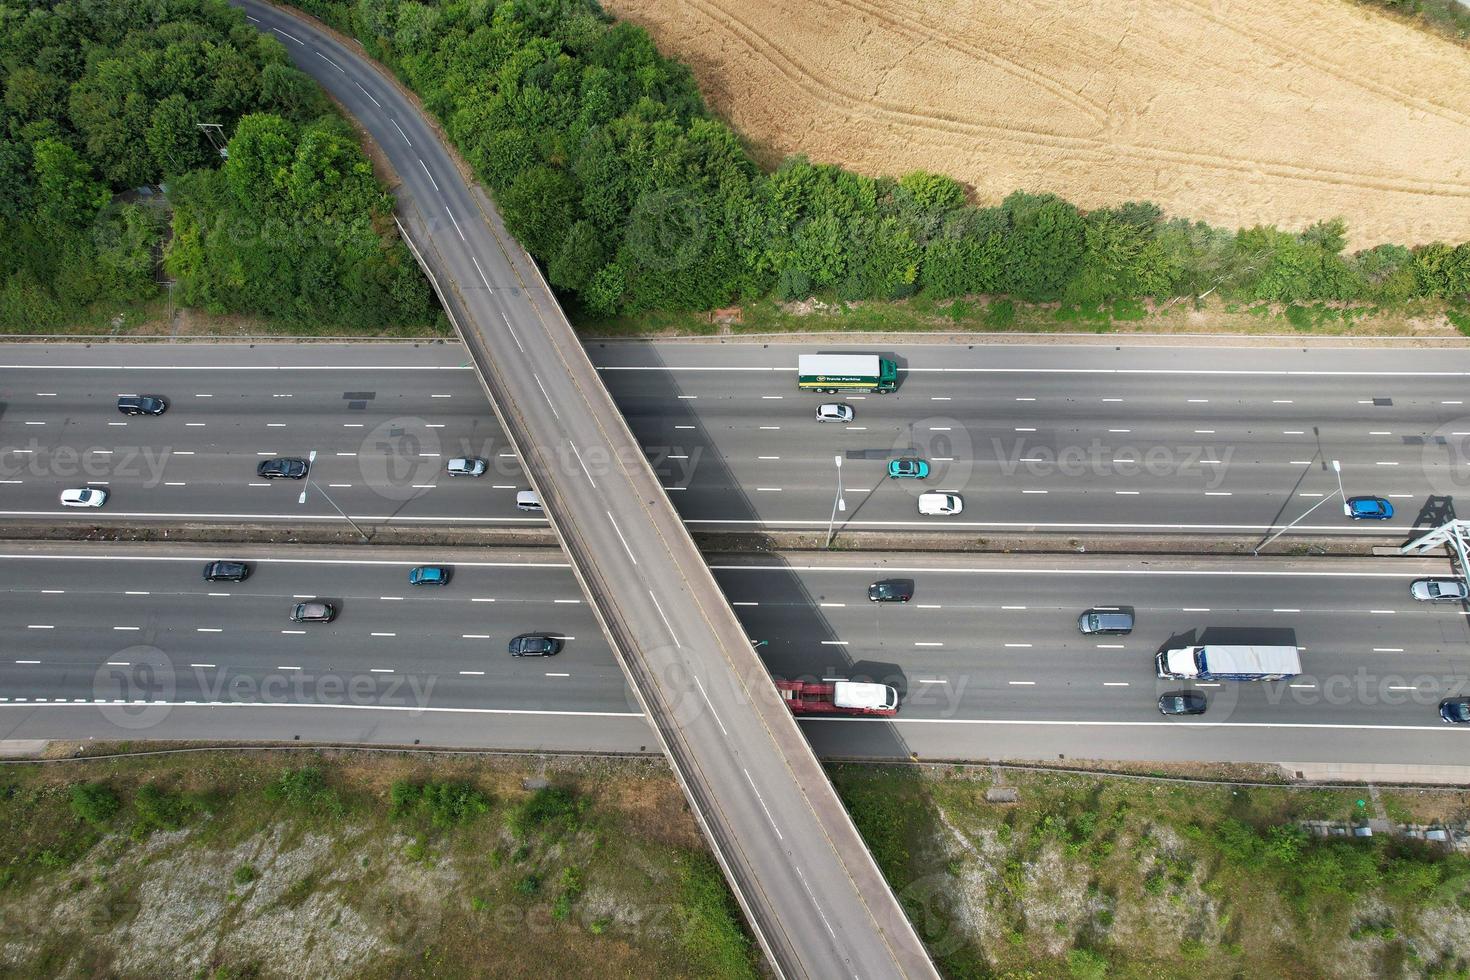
[{"xmin": 0, "ymin": 342, "xmax": 532, "ymax": 526}]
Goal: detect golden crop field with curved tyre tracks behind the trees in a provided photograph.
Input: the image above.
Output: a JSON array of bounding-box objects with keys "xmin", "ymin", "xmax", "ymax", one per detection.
[{"xmin": 604, "ymin": 0, "xmax": 1470, "ymax": 248}]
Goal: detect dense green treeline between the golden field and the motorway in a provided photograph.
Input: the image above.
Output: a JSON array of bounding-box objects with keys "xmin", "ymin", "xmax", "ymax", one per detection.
[{"xmin": 295, "ymin": 0, "xmax": 1470, "ymax": 313}]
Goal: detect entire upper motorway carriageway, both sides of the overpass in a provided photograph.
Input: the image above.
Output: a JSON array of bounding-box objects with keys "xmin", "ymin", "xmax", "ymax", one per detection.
[{"xmin": 0, "ymin": 341, "xmax": 1470, "ymax": 539}]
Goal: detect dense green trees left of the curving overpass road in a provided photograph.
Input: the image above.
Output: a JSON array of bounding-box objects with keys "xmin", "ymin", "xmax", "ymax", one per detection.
[{"xmin": 0, "ymin": 0, "xmax": 432, "ymax": 329}]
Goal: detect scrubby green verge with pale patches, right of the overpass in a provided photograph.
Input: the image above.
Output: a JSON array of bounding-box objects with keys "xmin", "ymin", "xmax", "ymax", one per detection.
[{"xmin": 831, "ymin": 765, "xmax": 1470, "ymax": 980}]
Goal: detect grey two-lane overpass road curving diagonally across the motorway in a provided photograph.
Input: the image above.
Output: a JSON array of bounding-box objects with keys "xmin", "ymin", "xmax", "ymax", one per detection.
[{"xmin": 237, "ymin": 0, "xmax": 938, "ymax": 977}]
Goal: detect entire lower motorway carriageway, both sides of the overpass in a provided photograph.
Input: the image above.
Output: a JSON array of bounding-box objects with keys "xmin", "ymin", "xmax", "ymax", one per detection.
[{"xmin": 0, "ymin": 544, "xmax": 1470, "ymax": 764}]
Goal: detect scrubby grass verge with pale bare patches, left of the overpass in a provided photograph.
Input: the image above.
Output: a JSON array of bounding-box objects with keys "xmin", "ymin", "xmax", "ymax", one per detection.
[{"xmin": 0, "ymin": 752, "xmax": 759, "ymax": 979}]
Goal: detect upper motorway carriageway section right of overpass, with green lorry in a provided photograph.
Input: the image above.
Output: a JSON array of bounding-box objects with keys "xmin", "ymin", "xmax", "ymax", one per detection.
[{"xmin": 589, "ymin": 342, "xmax": 1470, "ymax": 536}]
